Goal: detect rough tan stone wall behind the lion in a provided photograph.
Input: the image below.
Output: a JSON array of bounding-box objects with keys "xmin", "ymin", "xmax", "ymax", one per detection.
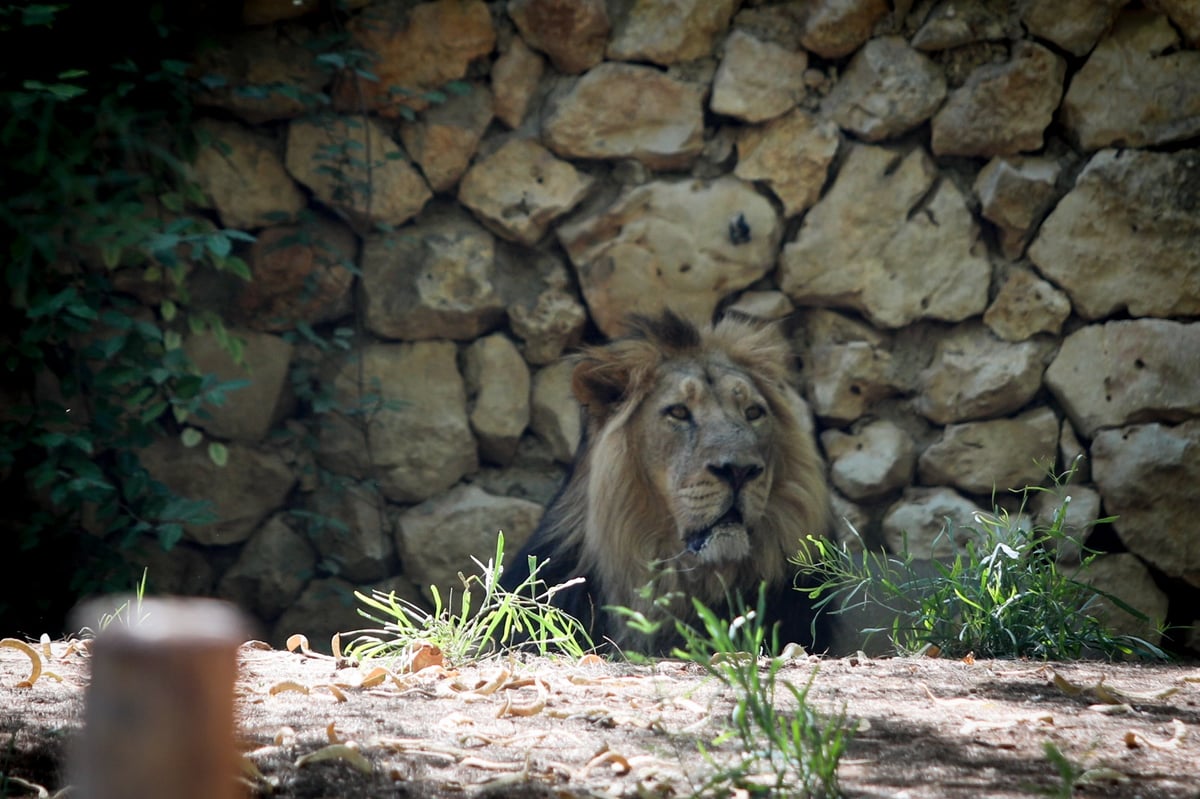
[{"xmin": 145, "ymin": 0, "xmax": 1200, "ymax": 645}]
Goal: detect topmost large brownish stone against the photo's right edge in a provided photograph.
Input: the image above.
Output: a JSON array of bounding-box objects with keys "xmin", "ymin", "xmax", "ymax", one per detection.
[{"xmin": 1062, "ymin": 11, "xmax": 1200, "ymax": 150}]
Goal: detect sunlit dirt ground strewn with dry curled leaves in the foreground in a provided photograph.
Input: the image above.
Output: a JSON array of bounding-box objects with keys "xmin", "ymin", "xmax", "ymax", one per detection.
[{"xmin": 0, "ymin": 642, "xmax": 1200, "ymax": 799}]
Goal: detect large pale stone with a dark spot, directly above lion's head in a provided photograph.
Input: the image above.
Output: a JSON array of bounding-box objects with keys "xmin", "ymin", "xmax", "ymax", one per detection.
[{"xmin": 558, "ymin": 178, "xmax": 781, "ymax": 336}]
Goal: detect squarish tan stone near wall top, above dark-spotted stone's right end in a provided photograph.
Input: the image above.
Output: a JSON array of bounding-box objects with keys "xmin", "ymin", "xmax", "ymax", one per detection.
[{"xmin": 708, "ymin": 30, "xmax": 809, "ymax": 122}]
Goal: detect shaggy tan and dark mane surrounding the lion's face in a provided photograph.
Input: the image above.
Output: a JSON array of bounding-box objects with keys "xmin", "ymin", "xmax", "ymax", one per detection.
[{"xmin": 505, "ymin": 312, "xmax": 829, "ymax": 649}]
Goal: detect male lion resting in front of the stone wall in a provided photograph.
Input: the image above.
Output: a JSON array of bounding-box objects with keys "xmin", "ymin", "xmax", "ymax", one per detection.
[{"xmin": 503, "ymin": 311, "xmax": 829, "ymax": 653}]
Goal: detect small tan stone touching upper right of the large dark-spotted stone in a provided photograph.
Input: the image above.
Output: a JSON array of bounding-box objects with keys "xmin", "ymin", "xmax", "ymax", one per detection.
[{"xmin": 733, "ymin": 109, "xmax": 840, "ymax": 216}]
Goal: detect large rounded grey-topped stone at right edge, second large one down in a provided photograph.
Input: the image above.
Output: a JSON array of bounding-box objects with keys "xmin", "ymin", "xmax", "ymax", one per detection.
[{"xmin": 1030, "ymin": 150, "xmax": 1200, "ymax": 319}]
